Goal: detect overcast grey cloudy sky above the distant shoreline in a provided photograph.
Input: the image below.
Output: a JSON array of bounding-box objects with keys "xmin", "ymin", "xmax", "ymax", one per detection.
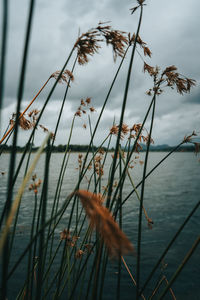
[{"xmin": 1, "ymin": 0, "xmax": 200, "ymax": 145}]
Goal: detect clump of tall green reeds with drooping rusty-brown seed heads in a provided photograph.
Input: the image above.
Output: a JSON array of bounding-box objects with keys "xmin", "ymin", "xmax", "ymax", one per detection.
[{"xmin": 0, "ymin": 0, "xmax": 200, "ymax": 300}]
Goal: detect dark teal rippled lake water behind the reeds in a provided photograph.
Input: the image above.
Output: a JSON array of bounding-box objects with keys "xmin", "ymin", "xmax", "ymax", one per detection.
[{"xmin": 0, "ymin": 152, "xmax": 200, "ymax": 300}]
